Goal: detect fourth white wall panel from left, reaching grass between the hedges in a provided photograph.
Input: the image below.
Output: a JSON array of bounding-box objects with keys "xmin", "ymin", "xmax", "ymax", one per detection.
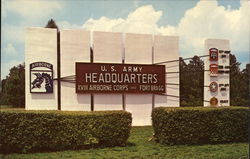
[{"xmin": 124, "ymin": 33, "xmax": 152, "ymax": 126}]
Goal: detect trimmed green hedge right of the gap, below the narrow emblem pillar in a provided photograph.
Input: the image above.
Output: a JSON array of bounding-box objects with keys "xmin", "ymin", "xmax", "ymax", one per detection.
[{"xmin": 152, "ymin": 107, "xmax": 249, "ymax": 145}]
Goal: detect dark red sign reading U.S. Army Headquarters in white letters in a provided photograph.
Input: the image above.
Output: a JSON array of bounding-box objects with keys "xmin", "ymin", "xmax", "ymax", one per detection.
[{"xmin": 76, "ymin": 63, "xmax": 166, "ymax": 93}]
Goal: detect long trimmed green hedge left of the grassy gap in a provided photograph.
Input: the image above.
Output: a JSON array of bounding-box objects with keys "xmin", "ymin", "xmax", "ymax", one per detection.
[{"xmin": 0, "ymin": 110, "xmax": 132, "ymax": 153}]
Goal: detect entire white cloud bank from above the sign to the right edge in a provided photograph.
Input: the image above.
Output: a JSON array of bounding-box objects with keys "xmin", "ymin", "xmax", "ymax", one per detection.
[{"xmin": 83, "ymin": 0, "xmax": 250, "ymax": 59}]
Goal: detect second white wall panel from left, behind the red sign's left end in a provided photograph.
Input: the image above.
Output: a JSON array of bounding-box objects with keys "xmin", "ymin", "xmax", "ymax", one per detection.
[{"xmin": 61, "ymin": 29, "xmax": 90, "ymax": 111}]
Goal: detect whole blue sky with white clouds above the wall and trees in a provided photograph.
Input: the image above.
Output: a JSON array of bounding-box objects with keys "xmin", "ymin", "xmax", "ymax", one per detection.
[{"xmin": 1, "ymin": 0, "xmax": 250, "ymax": 79}]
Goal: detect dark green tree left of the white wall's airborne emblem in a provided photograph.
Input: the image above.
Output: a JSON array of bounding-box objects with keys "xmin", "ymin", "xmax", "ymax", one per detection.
[{"xmin": 1, "ymin": 64, "xmax": 25, "ymax": 107}]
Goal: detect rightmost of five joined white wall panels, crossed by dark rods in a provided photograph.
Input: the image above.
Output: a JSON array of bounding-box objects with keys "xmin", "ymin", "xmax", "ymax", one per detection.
[{"xmin": 154, "ymin": 35, "xmax": 180, "ymax": 107}]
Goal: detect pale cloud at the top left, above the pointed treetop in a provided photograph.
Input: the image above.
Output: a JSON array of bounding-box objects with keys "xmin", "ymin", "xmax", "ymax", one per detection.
[{"xmin": 3, "ymin": 0, "xmax": 62, "ymax": 19}]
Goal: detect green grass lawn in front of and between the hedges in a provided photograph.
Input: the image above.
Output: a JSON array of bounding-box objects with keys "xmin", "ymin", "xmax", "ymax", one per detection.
[{"xmin": 0, "ymin": 126, "xmax": 249, "ymax": 159}]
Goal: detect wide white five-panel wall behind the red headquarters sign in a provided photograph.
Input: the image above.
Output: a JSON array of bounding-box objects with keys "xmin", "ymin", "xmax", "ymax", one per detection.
[{"xmin": 25, "ymin": 28, "xmax": 180, "ymax": 125}]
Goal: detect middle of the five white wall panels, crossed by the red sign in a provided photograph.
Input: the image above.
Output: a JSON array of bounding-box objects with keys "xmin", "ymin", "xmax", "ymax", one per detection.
[{"xmin": 93, "ymin": 32, "xmax": 123, "ymax": 110}]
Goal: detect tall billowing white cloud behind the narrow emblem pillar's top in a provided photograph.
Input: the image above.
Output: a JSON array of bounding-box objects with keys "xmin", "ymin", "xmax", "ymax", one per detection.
[{"xmin": 174, "ymin": 0, "xmax": 250, "ymax": 54}]
